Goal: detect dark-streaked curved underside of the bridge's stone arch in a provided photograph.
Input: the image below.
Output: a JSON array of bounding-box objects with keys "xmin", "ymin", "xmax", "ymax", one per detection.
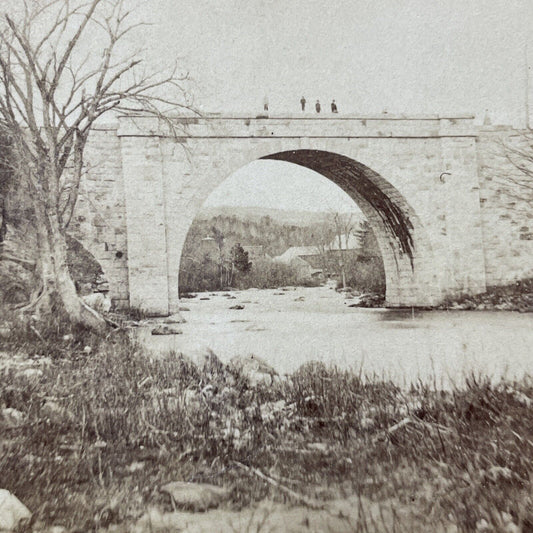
[{"xmin": 180, "ymin": 149, "xmax": 442, "ymax": 307}]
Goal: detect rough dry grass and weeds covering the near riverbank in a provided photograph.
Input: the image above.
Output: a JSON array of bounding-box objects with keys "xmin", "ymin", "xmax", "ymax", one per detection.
[{"xmin": 0, "ymin": 318, "xmax": 533, "ymax": 532}]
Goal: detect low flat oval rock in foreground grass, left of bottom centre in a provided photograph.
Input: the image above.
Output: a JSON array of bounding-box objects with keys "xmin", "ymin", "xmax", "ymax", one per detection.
[{"xmin": 160, "ymin": 481, "xmax": 230, "ymax": 511}]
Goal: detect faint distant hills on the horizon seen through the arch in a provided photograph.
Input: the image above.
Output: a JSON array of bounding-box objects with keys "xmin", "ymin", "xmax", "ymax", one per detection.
[{"xmin": 197, "ymin": 206, "xmax": 365, "ymax": 228}]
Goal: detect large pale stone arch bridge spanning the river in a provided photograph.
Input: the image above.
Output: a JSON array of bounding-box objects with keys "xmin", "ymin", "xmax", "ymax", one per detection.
[{"xmin": 71, "ymin": 115, "xmax": 533, "ymax": 315}]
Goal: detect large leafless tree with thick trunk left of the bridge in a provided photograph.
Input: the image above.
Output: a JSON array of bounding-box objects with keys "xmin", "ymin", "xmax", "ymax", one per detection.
[{"xmin": 0, "ymin": 0, "xmax": 192, "ymax": 328}]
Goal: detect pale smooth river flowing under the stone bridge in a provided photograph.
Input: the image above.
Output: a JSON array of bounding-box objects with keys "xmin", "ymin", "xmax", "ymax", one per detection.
[{"xmin": 139, "ymin": 286, "xmax": 533, "ymax": 387}]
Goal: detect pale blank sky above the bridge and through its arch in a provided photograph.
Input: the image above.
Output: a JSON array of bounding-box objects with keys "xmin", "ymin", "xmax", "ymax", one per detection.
[{"xmin": 143, "ymin": 0, "xmax": 533, "ymax": 210}]
